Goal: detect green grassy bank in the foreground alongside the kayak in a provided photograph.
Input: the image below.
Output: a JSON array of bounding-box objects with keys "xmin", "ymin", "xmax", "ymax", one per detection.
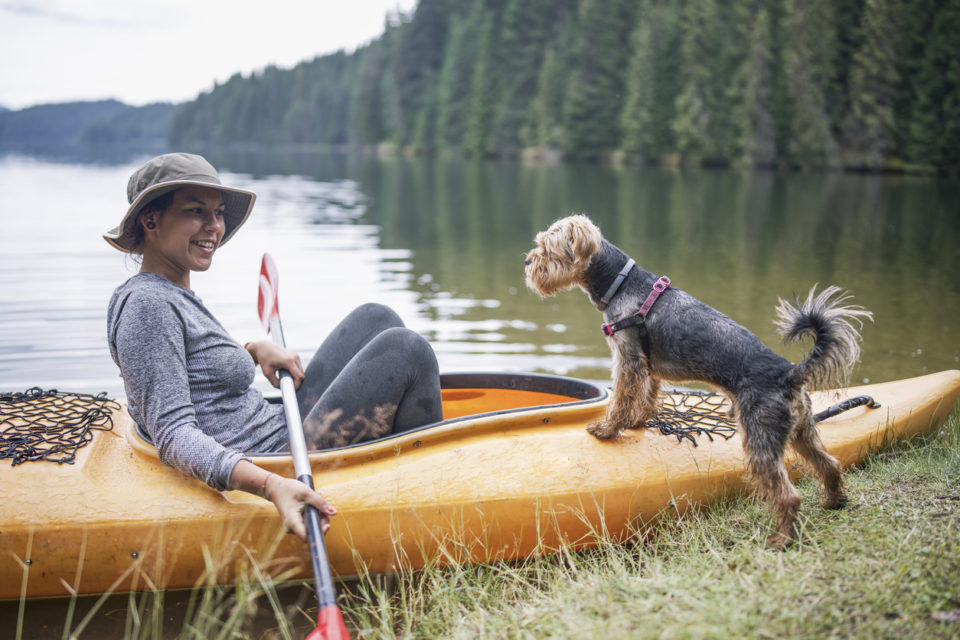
[{"xmin": 9, "ymin": 408, "xmax": 960, "ymax": 640}]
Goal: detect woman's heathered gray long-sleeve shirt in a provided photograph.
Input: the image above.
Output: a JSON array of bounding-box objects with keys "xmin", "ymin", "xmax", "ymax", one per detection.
[{"xmin": 107, "ymin": 273, "xmax": 286, "ymax": 490}]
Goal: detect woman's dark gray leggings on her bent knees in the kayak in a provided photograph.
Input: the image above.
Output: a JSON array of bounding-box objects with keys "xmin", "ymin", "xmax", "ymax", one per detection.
[{"xmin": 297, "ymin": 303, "xmax": 443, "ymax": 449}]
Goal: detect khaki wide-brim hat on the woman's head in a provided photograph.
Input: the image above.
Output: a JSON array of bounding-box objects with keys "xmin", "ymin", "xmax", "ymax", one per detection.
[{"xmin": 103, "ymin": 153, "xmax": 257, "ymax": 253}]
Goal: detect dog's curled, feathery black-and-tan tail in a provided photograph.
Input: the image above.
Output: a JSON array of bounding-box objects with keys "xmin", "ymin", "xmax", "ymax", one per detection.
[{"xmin": 776, "ymin": 286, "xmax": 873, "ymax": 389}]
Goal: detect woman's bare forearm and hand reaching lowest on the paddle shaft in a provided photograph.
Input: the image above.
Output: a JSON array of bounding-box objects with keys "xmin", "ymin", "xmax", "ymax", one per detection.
[{"xmin": 230, "ymin": 459, "xmax": 337, "ymax": 542}]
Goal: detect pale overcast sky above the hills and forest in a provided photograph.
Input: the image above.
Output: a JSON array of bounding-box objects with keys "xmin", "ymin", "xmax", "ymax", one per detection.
[{"xmin": 0, "ymin": 0, "xmax": 416, "ymax": 109}]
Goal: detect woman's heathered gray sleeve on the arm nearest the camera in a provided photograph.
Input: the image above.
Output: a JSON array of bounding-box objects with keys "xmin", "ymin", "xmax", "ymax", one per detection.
[{"xmin": 110, "ymin": 290, "xmax": 242, "ymax": 490}]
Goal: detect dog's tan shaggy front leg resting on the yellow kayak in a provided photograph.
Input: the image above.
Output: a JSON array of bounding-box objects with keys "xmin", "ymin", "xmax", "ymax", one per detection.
[{"xmin": 587, "ymin": 349, "xmax": 660, "ymax": 440}]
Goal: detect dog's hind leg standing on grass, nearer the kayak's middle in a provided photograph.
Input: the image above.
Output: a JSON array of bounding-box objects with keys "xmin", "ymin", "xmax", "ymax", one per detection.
[{"xmin": 740, "ymin": 401, "xmax": 801, "ymax": 549}]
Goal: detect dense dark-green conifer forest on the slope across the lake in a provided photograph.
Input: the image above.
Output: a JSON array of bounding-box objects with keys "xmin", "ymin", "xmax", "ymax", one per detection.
[{"xmin": 159, "ymin": 0, "xmax": 960, "ymax": 175}]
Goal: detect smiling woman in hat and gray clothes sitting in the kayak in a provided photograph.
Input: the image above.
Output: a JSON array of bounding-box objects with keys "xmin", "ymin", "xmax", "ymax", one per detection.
[{"xmin": 104, "ymin": 153, "xmax": 442, "ymax": 540}]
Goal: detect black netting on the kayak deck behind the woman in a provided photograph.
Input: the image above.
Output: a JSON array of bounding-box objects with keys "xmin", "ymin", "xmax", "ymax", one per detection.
[{"xmin": 0, "ymin": 387, "xmax": 120, "ymax": 466}]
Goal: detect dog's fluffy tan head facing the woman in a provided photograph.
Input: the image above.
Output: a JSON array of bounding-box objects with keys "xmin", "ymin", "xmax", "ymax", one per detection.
[{"xmin": 524, "ymin": 214, "xmax": 603, "ymax": 298}]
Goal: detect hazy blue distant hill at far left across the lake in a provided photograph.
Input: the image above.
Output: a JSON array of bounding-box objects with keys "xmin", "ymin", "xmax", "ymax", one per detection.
[{"xmin": 0, "ymin": 100, "xmax": 174, "ymax": 151}]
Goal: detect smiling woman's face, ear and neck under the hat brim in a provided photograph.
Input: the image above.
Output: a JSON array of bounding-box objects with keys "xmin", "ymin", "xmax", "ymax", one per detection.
[{"xmin": 141, "ymin": 186, "xmax": 226, "ymax": 286}]
